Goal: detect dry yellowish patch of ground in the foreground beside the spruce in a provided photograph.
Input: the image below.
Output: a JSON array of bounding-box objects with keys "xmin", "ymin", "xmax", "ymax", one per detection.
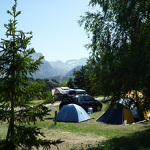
[{"xmin": 40, "ymin": 130, "xmax": 106, "ymax": 150}]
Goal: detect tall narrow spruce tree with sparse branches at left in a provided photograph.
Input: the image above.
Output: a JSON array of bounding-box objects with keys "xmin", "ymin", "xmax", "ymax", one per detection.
[{"xmin": 0, "ymin": 0, "xmax": 61, "ymax": 150}]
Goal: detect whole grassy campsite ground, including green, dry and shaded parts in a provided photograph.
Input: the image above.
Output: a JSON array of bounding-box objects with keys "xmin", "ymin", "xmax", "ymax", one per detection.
[{"xmin": 0, "ymin": 101, "xmax": 150, "ymax": 150}]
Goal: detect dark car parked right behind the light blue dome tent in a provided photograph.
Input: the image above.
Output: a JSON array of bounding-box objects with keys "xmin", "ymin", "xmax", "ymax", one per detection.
[{"xmin": 59, "ymin": 94, "xmax": 102, "ymax": 112}]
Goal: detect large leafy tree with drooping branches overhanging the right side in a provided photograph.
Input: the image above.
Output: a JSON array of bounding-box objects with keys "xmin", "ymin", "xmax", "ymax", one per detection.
[{"xmin": 79, "ymin": 0, "xmax": 150, "ymax": 99}]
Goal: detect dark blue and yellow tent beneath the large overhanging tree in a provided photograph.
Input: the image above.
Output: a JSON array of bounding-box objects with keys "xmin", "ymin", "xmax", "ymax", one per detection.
[{"xmin": 96, "ymin": 90, "xmax": 150, "ymax": 124}]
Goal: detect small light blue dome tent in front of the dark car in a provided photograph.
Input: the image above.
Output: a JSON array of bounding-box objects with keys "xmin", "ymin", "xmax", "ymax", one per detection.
[{"xmin": 57, "ymin": 104, "xmax": 91, "ymax": 122}]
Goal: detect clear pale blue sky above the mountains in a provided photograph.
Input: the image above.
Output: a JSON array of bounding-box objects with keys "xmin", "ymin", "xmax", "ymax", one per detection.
[{"xmin": 0, "ymin": 0, "xmax": 90, "ymax": 62}]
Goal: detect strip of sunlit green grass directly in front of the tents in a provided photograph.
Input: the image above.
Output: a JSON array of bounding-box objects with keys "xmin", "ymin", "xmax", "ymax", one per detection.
[{"xmin": 37, "ymin": 106, "xmax": 149, "ymax": 138}]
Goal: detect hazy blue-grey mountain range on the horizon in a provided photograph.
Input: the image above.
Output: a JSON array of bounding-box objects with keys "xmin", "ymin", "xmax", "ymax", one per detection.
[{"xmin": 32, "ymin": 53, "xmax": 87, "ymax": 79}]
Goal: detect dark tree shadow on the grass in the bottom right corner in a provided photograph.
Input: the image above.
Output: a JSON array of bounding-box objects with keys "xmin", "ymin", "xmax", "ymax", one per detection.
[{"xmin": 87, "ymin": 125, "xmax": 150, "ymax": 150}]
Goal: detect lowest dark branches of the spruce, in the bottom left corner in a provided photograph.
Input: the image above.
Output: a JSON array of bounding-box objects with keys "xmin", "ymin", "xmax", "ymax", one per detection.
[{"xmin": 0, "ymin": 126, "xmax": 61, "ymax": 150}]
